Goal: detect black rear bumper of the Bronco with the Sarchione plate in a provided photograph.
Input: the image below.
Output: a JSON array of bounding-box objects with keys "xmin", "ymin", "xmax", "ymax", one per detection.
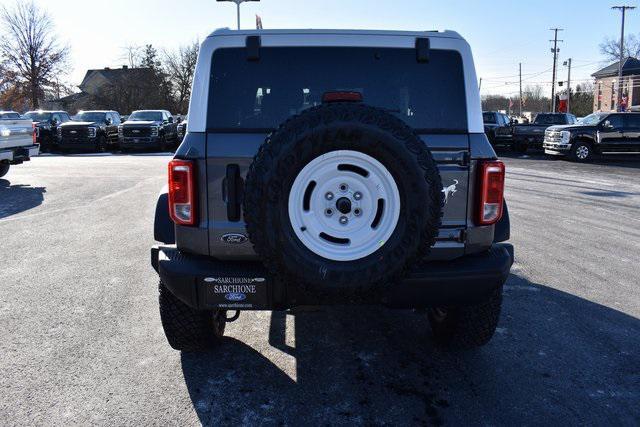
[{"xmin": 151, "ymin": 243, "xmax": 514, "ymax": 310}]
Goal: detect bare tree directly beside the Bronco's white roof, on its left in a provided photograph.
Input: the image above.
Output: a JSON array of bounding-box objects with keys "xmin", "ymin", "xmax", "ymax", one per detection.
[{"xmin": 164, "ymin": 41, "xmax": 200, "ymax": 113}]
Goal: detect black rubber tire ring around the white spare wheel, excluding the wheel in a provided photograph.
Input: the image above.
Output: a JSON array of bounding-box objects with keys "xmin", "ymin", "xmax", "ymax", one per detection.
[{"xmin": 243, "ymin": 103, "xmax": 444, "ymax": 297}]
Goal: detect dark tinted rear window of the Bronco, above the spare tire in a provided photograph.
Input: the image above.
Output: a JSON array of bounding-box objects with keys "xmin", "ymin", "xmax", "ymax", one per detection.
[{"xmin": 207, "ymin": 47, "xmax": 467, "ymax": 133}]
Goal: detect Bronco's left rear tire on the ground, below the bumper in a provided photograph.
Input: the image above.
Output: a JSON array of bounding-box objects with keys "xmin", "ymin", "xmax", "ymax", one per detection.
[{"xmin": 158, "ymin": 282, "xmax": 226, "ymax": 351}]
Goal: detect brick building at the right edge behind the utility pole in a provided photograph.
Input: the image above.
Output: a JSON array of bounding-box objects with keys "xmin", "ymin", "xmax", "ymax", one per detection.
[{"xmin": 591, "ymin": 57, "xmax": 640, "ymax": 111}]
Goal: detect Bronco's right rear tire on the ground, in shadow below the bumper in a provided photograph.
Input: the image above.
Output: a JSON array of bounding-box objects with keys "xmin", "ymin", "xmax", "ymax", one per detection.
[{"xmin": 428, "ymin": 286, "xmax": 502, "ymax": 350}]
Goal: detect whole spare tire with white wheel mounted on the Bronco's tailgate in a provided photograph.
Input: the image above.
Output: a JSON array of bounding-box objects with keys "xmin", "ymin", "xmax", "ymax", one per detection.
[{"xmin": 243, "ymin": 103, "xmax": 443, "ymax": 292}]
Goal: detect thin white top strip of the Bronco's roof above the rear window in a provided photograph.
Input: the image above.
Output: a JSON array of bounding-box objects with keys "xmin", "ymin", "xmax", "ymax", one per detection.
[{"xmin": 209, "ymin": 28, "xmax": 462, "ymax": 39}]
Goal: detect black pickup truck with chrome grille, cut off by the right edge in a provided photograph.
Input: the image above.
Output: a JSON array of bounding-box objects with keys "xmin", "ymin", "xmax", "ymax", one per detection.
[{"xmin": 544, "ymin": 113, "xmax": 640, "ymax": 162}]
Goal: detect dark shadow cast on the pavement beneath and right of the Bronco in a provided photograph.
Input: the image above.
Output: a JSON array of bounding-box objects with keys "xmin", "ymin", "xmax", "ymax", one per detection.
[{"xmin": 182, "ymin": 275, "xmax": 640, "ymax": 425}]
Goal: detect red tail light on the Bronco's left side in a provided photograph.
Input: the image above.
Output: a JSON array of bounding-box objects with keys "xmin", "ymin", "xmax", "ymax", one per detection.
[{"xmin": 169, "ymin": 160, "xmax": 196, "ymax": 225}]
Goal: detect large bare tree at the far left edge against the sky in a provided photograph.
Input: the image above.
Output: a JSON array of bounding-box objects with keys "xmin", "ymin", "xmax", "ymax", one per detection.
[{"xmin": 0, "ymin": 1, "xmax": 68, "ymax": 108}]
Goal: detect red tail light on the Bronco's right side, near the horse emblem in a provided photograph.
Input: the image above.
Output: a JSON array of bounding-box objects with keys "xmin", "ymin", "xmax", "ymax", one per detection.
[{"xmin": 476, "ymin": 160, "xmax": 505, "ymax": 225}]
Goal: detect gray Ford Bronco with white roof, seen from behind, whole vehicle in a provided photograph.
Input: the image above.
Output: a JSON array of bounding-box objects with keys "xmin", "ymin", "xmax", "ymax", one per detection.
[{"xmin": 151, "ymin": 29, "xmax": 513, "ymax": 351}]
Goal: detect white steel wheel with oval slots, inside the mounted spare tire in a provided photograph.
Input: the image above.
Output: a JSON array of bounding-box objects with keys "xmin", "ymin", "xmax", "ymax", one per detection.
[{"xmin": 288, "ymin": 150, "xmax": 400, "ymax": 261}]
